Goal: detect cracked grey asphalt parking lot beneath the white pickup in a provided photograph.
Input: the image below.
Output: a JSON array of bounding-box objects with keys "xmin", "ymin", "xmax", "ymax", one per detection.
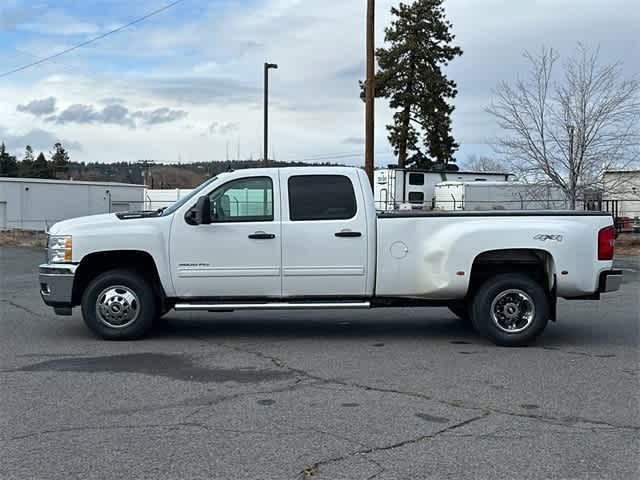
[{"xmin": 0, "ymin": 248, "xmax": 640, "ymax": 480}]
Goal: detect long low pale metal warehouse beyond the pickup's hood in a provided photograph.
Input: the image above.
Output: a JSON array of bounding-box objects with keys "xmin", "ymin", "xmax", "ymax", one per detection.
[{"xmin": 0, "ymin": 177, "xmax": 144, "ymax": 230}]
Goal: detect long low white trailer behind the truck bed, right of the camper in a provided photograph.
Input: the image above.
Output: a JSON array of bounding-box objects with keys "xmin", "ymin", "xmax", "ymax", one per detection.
[{"xmin": 434, "ymin": 182, "xmax": 568, "ymax": 211}]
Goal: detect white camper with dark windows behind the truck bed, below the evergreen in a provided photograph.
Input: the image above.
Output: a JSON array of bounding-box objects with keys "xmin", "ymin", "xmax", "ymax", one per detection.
[{"xmin": 373, "ymin": 166, "xmax": 513, "ymax": 210}]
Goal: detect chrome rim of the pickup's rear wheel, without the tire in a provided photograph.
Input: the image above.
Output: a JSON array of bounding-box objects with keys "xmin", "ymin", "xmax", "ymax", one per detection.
[{"xmin": 491, "ymin": 289, "xmax": 536, "ymax": 333}]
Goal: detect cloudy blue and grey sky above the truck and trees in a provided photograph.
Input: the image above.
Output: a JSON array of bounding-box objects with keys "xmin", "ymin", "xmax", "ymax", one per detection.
[{"xmin": 0, "ymin": 0, "xmax": 640, "ymax": 166}]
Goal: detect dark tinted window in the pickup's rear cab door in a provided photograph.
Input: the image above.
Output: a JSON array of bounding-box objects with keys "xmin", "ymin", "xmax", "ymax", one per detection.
[{"xmin": 288, "ymin": 175, "xmax": 358, "ymax": 222}]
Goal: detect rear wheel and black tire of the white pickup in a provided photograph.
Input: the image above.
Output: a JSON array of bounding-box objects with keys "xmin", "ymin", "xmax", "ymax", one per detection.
[{"xmin": 470, "ymin": 273, "xmax": 550, "ymax": 347}]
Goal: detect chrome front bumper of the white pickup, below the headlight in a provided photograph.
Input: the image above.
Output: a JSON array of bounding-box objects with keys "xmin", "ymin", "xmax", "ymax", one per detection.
[{"xmin": 38, "ymin": 264, "xmax": 78, "ymax": 315}]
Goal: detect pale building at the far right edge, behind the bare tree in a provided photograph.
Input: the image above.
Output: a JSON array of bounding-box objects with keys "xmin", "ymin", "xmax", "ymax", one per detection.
[{"xmin": 604, "ymin": 169, "xmax": 640, "ymax": 218}]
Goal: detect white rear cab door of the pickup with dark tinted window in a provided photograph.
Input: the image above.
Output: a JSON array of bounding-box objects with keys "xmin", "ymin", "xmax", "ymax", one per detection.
[{"xmin": 280, "ymin": 170, "xmax": 368, "ymax": 297}]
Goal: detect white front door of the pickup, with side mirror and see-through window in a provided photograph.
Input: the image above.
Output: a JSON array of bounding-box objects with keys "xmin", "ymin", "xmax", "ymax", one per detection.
[{"xmin": 171, "ymin": 170, "xmax": 282, "ymax": 298}]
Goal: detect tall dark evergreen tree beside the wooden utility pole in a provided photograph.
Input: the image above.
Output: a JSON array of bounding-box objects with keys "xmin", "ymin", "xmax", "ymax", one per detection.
[{"xmin": 360, "ymin": 0, "xmax": 462, "ymax": 168}]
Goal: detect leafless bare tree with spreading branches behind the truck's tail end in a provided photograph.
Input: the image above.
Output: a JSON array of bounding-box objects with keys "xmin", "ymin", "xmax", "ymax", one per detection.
[{"xmin": 487, "ymin": 44, "xmax": 640, "ymax": 208}]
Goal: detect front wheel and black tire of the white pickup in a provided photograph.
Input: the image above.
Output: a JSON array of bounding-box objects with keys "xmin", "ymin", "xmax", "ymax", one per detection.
[{"xmin": 82, "ymin": 269, "xmax": 158, "ymax": 340}]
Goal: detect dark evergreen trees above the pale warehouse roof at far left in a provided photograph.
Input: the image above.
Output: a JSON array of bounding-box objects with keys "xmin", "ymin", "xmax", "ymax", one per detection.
[{"xmin": 0, "ymin": 142, "xmax": 69, "ymax": 178}]
